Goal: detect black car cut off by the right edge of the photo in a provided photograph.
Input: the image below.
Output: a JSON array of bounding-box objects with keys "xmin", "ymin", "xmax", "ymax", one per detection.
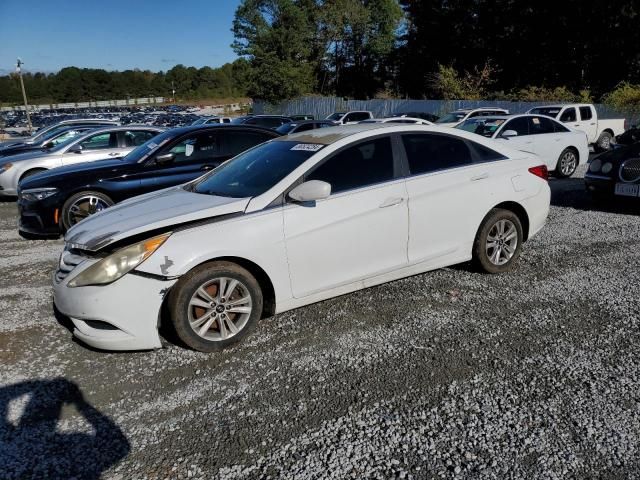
[{"xmin": 584, "ymin": 143, "xmax": 640, "ymax": 200}]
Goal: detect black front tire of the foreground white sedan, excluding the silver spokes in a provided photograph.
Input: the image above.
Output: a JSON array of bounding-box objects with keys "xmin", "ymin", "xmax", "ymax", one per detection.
[{"xmin": 168, "ymin": 261, "xmax": 263, "ymax": 353}]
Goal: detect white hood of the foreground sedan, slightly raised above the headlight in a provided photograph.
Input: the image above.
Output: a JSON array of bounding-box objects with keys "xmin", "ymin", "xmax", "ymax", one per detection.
[{"xmin": 65, "ymin": 186, "xmax": 250, "ymax": 251}]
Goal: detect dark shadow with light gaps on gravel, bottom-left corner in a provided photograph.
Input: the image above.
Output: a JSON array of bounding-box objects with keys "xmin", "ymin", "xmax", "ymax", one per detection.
[{"xmin": 0, "ymin": 378, "xmax": 131, "ymax": 479}]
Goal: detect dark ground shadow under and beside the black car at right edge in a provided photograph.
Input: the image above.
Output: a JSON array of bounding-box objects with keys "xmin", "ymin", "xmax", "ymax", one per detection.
[{"xmin": 549, "ymin": 178, "xmax": 640, "ymax": 215}]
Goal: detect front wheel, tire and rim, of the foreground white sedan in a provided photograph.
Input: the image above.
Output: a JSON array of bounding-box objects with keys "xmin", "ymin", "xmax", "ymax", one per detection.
[{"xmin": 169, "ymin": 261, "xmax": 263, "ymax": 352}]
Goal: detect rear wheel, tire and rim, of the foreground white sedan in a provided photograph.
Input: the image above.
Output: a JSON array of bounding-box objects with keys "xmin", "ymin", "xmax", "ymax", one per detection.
[{"xmin": 472, "ymin": 208, "xmax": 524, "ymax": 273}]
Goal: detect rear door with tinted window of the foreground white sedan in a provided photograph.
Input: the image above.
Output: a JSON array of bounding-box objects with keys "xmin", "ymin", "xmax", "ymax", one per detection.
[{"xmin": 402, "ymin": 133, "xmax": 505, "ymax": 264}]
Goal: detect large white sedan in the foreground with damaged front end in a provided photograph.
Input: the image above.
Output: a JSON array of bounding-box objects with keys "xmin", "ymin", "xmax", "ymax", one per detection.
[{"xmin": 54, "ymin": 124, "xmax": 550, "ymax": 352}]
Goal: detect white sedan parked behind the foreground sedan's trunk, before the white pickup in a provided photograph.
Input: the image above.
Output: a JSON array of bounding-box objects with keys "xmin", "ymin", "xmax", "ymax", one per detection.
[{"xmin": 456, "ymin": 115, "xmax": 589, "ymax": 177}]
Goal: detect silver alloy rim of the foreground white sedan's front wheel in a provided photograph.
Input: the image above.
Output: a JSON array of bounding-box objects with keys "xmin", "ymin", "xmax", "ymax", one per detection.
[{"xmin": 189, "ymin": 277, "xmax": 253, "ymax": 342}]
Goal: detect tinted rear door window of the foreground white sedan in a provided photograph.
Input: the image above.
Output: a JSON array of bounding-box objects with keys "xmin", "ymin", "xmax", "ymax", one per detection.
[{"xmin": 402, "ymin": 134, "xmax": 473, "ymax": 175}]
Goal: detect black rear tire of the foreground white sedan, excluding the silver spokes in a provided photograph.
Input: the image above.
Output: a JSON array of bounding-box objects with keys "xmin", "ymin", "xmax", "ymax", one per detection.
[{"xmin": 472, "ymin": 208, "xmax": 524, "ymax": 274}]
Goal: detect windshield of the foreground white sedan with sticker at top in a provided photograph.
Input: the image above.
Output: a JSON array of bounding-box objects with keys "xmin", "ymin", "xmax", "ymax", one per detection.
[{"xmin": 185, "ymin": 141, "xmax": 324, "ymax": 198}]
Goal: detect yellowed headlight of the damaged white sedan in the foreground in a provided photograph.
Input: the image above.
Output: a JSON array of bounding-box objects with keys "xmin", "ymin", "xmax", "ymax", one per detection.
[{"xmin": 68, "ymin": 232, "xmax": 171, "ymax": 287}]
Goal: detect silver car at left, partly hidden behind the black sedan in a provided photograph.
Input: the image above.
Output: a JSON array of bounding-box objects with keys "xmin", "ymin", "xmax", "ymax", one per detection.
[{"xmin": 0, "ymin": 125, "xmax": 165, "ymax": 196}]
